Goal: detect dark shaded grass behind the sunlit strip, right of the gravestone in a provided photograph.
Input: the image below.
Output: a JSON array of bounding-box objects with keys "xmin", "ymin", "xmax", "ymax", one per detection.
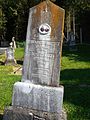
[{"xmin": 62, "ymin": 45, "xmax": 90, "ymax": 62}]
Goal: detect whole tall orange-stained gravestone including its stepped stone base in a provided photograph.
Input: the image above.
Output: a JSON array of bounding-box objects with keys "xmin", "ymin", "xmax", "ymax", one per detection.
[{"xmin": 4, "ymin": 1, "xmax": 66, "ymax": 120}]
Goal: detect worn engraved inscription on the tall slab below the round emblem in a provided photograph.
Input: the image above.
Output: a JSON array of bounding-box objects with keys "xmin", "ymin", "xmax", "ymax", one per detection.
[{"xmin": 29, "ymin": 40, "xmax": 60, "ymax": 81}]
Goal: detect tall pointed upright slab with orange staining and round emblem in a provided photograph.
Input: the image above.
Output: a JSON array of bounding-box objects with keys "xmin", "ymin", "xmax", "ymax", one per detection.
[{"xmin": 22, "ymin": 1, "xmax": 65, "ymax": 86}]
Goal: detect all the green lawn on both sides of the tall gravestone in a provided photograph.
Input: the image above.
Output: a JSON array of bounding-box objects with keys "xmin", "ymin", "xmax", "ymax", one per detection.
[{"xmin": 0, "ymin": 45, "xmax": 90, "ymax": 120}]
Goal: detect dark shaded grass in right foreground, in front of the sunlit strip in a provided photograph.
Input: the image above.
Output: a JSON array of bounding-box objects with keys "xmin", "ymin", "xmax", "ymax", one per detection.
[{"xmin": 61, "ymin": 69, "xmax": 90, "ymax": 120}]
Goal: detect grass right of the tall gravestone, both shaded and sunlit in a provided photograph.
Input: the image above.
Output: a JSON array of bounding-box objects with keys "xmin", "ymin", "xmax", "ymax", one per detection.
[{"xmin": 61, "ymin": 45, "xmax": 90, "ymax": 120}]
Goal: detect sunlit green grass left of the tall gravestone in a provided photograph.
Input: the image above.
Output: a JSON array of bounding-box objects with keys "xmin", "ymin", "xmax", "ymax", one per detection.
[{"xmin": 0, "ymin": 48, "xmax": 24, "ymax": 114}]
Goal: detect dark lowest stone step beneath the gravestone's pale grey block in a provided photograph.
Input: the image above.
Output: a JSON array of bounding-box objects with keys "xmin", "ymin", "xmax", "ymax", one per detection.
[{"xmin": 3, "ymin": 106, "xmax": 67, "ymax": 120}]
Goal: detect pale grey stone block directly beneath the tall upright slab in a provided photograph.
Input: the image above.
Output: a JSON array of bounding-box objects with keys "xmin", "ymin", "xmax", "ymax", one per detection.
[{"xmin": 12, "ymin": 82, "xmax": 63, "ymax": 120}]
